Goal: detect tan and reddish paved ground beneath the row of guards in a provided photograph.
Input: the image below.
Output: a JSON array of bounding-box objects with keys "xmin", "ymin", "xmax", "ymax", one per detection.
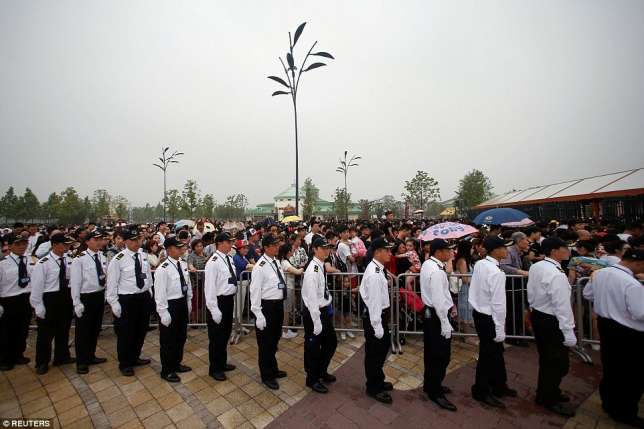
[{"xmin": 0, "ymin": 329, "xmax": 644, "ymax": 429}]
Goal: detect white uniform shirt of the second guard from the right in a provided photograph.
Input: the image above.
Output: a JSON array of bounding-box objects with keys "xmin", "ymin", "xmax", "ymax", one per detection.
[{"xmin": 527, "ymin": 257, "xmax": 575, "ymax": 339}]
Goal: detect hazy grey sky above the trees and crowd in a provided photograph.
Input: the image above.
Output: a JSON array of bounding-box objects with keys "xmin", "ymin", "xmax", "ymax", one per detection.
[{"xmin": 0, "ymin": 0, "xmax": 644, "ymax": 205}]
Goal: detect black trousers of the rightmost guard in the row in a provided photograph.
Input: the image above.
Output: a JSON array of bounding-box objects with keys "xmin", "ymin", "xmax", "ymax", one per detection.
[{"xmin": 597, "ymin": 317, "xmax": 644, "ymax": 420}]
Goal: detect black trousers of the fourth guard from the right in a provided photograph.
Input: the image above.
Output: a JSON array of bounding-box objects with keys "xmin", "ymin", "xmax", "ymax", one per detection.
[{"xmin": 423, "ymin": 307, "xmax": 452, "ymax": 398}]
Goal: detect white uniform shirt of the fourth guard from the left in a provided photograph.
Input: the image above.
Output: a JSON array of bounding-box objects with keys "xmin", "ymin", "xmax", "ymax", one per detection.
[{"xmin": 105, "ymin": 248, "xmax": 152, "ymax": 305}]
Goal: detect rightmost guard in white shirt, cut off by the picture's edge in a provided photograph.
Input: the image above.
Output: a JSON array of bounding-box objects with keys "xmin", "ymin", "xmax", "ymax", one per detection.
[{"xmin": 584, "ymin": 249, "xmax": 644, "ymax": 428}]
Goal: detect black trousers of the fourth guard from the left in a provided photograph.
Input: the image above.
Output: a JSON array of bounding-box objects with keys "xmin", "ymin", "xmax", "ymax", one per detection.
[{"xmin": 114, "ymin": 291, "xmax": 152, "ymax": 369}]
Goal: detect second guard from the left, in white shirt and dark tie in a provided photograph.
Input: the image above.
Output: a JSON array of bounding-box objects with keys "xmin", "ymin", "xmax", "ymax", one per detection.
[{"xmin": 29, "ymin": 234, "xmax": 76, "ymax": 374}]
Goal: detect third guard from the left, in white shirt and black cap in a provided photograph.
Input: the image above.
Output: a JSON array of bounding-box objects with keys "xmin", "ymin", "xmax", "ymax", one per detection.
[{"xmin": 69, "ymin": 230, "xmax": 107, "ymax": 374}]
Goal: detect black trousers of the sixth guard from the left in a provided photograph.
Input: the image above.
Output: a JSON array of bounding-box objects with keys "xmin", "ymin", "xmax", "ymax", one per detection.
[{"xmin": 206, "ymin": 294, "xmax": 235, "ymax": 375}]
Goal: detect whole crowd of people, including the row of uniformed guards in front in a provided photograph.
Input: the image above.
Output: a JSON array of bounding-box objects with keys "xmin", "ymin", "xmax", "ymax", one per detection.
[{"xmin": 0, "ymin": 212, "xmax": 644, "ymax": 424}]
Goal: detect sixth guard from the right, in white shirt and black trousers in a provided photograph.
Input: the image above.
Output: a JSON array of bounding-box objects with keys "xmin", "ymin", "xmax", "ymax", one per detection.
[{"xmin": 302, "ymin": 237, "xmax": 338, "ymax": 393}]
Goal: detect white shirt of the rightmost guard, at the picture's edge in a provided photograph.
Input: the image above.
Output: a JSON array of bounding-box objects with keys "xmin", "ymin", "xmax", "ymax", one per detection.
[{"xmin": 584, "ymin": 265, "xmax": 644, "ymax": 332}]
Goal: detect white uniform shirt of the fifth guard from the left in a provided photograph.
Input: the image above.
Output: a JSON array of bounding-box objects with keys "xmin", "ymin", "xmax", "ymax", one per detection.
[{"xmin": 154, "ymin": 257, "xmax": 192, "ymax": 314}]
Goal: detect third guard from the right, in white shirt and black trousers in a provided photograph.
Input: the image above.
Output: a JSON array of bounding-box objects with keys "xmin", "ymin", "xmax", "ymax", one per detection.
[{"xmin": 468, "ymin": 235, "xmax": 517, "ymax": 408}]
